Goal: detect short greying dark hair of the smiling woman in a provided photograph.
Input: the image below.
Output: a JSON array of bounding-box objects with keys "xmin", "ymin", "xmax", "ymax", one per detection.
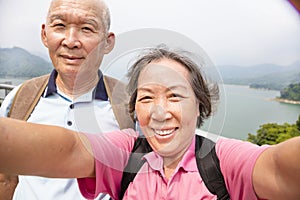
[{"xmin": 127, "ymin": 45, "xmax": 219, "ymax": 128}]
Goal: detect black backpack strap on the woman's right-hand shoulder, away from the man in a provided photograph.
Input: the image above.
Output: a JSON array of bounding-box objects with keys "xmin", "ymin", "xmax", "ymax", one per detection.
[{"xmin": 195, "ymin": 135, "xmax": 230, "ymax": 200}]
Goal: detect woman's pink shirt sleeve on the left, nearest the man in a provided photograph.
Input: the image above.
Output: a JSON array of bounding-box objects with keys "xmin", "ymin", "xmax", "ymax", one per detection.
[{"xmin": 77, "ymin": 129, "xmax": 138, "ymax": 199}]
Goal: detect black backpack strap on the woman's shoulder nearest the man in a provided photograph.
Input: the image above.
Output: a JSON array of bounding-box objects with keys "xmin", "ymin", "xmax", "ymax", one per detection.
[{"xmin": 119, "ymin": 137, "xmax": 152, "ymax": 199}]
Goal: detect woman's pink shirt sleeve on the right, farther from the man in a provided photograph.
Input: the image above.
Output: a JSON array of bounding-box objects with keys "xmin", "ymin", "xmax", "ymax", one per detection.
[{"xmin": 216, "ymin": 138, "xmax": 269, "ymax": 200}]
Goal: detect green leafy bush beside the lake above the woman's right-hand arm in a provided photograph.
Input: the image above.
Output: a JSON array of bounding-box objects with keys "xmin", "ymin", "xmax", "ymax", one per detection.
[{"xmin": 247, "ymin": 115, "xmax": 300, "ymax": 145}]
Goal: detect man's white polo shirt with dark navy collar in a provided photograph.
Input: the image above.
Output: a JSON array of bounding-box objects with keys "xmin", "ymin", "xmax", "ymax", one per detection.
[{"xmin": 0, "ymin": 70, "xmax": 119, "ymax": 200}]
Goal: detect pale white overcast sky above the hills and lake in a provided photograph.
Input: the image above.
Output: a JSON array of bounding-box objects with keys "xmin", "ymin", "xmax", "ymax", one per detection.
[{"xmin": 0, "ymin": 0, "xmax": 300, "ymax": 66}]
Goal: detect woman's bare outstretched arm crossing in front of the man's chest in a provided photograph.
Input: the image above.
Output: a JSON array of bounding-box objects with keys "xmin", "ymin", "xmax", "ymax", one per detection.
[{"xmin": 0, "ymin": 118, "xmax": 94, "ymax": 178}]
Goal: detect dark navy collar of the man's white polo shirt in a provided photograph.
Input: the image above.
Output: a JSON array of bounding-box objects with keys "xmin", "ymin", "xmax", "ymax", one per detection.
[{"xmin": 44, "ymin": 69, "xmax": 108, "ymax": 101}]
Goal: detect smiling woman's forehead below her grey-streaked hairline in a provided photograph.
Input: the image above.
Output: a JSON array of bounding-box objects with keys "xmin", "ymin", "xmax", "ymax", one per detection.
[{"xmin": 138, "ymin": 60, "xmax": 190, "ymax": 88}]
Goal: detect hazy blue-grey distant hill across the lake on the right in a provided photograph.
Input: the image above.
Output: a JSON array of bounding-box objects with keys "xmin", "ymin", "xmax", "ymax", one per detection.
[{"xmin": 219, "ymin": 60, "xmax": 300, "ymax": 90}]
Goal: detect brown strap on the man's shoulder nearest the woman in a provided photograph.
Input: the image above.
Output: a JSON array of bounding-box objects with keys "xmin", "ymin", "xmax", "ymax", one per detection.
[{"xmin": 103, "ymin": 75, "xmax": 134, "ymax": 129}]
